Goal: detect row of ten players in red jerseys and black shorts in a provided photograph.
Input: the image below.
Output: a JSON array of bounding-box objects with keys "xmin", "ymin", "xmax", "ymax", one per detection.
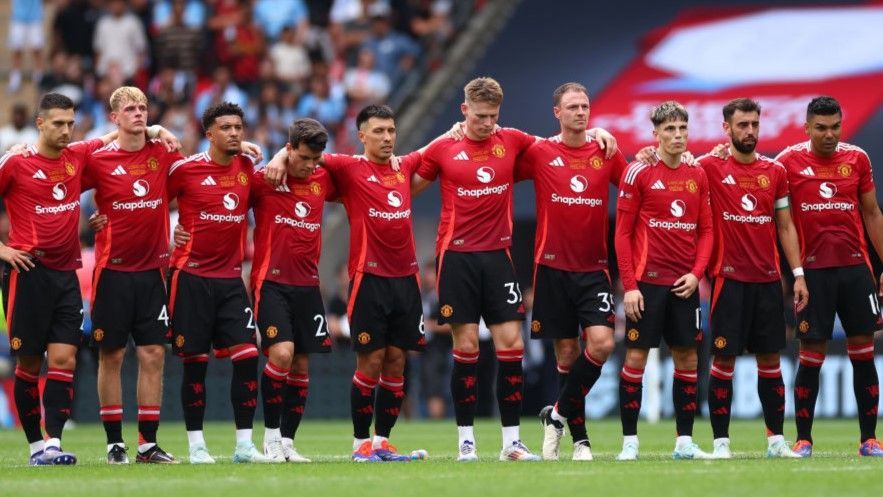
[{"xmin": 0, "ymin": 77, "xmax": 883, "ymax": 465}]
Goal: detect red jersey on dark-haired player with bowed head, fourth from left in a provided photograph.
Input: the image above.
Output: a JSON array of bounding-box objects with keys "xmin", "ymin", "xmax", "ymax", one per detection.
[{"xmin": 251, "ymin": 167, "xmax": 336, "ymax": 288}]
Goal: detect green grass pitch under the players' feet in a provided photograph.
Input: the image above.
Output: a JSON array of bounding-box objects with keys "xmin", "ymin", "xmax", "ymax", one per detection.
[{"xmin": 0, "ymin": 418, "xmax": 883, "ymax": 497}]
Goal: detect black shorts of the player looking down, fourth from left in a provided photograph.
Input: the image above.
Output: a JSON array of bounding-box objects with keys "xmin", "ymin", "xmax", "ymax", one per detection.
[{"xmin": 254, "ymin": 281, "xmax": 331, "ymax": 354}]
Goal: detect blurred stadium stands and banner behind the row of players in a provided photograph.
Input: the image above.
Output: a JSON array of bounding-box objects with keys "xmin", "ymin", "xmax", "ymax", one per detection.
[{"xmin": 0, "ymin": 0, "xmax": 883, "ymax": 426}]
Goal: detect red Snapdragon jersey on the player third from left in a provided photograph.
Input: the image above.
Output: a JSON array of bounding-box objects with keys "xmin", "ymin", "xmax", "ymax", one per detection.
[{"xmin": 168, "ymin": 152, "xmax": 254, "ymax": 278}]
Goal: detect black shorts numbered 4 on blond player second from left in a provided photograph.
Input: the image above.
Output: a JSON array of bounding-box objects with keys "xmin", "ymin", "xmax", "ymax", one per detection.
[{"xmin": 91, "ymin": 268, "xmax": 169, "ymax": 349}]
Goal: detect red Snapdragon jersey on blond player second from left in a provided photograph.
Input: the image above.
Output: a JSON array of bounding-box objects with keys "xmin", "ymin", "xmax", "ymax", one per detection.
[{"xmin": 83, "ymin": 140, "xmax": 182, "ymax": 271}]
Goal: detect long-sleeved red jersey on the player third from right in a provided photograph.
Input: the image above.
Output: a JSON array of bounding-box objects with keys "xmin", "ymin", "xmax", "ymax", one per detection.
[{"xmin": 615, "ymin": 161, "xmax": 712, "ymax": 291}]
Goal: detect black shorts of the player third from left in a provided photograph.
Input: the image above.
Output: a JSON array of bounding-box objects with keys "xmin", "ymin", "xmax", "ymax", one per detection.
[{"xmin": 169, "ymin": 270, "xmax": 255, "ymax": 355}]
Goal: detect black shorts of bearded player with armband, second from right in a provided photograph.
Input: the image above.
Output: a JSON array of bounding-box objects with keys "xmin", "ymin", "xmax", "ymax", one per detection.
[{"xmin": 711, "ymin": 278, "xmax": 785, "ymax": 356}]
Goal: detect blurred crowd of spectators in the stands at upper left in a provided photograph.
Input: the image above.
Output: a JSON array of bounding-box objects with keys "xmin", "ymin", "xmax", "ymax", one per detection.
[{"xmin": 8, "ymin": 0, "xmax": 483, "ymax": 154}]
